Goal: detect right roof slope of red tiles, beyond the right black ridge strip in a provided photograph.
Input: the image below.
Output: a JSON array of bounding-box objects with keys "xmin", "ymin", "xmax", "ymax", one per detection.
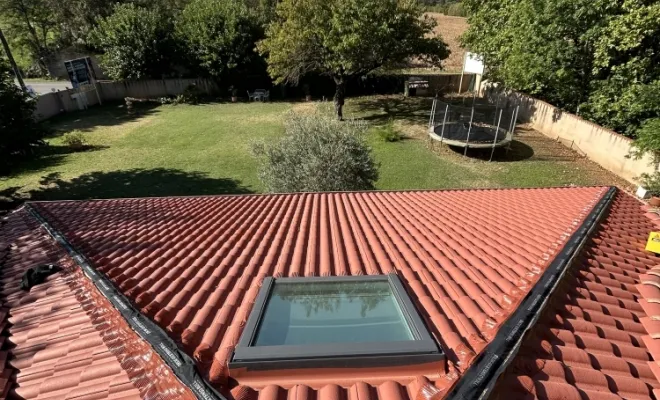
[{"xmin": 494, "ymin": 193, "xmax": 660, "ymax": 400}]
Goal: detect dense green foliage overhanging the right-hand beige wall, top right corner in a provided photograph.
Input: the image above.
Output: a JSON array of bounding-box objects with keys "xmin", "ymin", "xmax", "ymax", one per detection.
[{"xmin": 463, "ymin": 0, "xmax": 660, "ymax": 144}]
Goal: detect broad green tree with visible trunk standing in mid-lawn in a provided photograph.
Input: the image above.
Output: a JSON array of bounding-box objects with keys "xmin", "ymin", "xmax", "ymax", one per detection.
[{"xmin": 258, "ymin": 0, "xmax": 449, "ymax": 119}]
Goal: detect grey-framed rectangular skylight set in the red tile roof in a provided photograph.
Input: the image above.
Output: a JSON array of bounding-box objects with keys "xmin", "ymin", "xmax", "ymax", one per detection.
[{"xmin": 229, "ymin": 274, "xmax": 444, "ymax": 369}]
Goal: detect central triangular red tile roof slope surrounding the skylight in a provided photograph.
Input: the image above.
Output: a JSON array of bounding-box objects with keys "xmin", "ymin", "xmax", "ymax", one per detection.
[{"xmin": 28, "ymin": 188, "xmax": 606, "ymax": 400}]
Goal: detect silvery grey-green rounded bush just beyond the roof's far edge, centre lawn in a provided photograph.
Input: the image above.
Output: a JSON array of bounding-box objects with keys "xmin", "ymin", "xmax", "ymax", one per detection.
[{"xmin": 253, "ymin": 113, "xmax": 378, "ymax": 193}]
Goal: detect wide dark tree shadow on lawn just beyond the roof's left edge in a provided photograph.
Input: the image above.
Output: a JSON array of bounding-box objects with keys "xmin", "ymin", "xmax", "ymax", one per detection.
[{"xmin": 29, "ymin": 168, "xmax": 252, "ymax": 200}]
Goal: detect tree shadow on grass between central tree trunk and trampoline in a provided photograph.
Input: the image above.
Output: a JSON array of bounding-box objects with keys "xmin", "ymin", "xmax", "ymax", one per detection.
[{"xmin": 351, "ymin": 96, "xmax": 433, "ymax": 124}]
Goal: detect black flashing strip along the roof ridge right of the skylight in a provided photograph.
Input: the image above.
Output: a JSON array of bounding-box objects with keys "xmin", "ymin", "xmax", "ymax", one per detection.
[{"xmin": 445, "ymin": 187, "xmax": 617, "ymax": 400}]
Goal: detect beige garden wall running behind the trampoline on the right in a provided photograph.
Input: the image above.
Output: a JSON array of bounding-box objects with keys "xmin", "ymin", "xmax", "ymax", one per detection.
[{"xmin": 498, "ymin": 92, "xmax": 656, "ymax": 183}]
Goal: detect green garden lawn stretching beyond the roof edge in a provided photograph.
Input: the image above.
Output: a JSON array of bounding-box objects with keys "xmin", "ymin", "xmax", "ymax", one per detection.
[{"xmin": 0, "ymin": 96, "xmax": 620, "ymax": 205}]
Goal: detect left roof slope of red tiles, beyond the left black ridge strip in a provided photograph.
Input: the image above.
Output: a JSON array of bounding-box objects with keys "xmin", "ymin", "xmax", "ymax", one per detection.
[{"xmin": 0, "ymin": 210, "xmax": 192, "ymax": 400}]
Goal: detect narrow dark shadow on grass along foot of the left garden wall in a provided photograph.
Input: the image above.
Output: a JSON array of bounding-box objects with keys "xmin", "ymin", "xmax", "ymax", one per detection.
[{"xmin": 43, "ymin": 102, "xmax": 160, "ymax": 136}]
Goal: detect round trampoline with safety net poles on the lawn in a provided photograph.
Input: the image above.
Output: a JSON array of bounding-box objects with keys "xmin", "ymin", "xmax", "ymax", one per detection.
[{"xmin": 429, "ymin": 99, "xmax": 518, "ymax": 160}]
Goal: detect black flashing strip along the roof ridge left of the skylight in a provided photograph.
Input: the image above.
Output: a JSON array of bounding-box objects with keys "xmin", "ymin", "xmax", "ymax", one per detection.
[{"xmin": 25, "ymin": 203, "xmax": 227, "ymax": 400}]
